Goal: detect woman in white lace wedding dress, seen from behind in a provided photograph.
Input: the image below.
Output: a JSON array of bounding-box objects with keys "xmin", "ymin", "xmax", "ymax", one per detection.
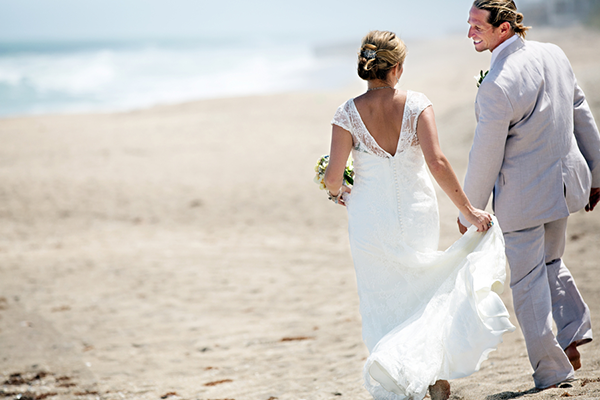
[{"xmin": 325, "ymin": 31, "xmax": 514, "ymax": 400}]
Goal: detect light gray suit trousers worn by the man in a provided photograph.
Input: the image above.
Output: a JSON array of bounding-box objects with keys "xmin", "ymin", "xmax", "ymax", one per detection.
[{"xmin": 504, "ymin": 218, "xmax": 592, "ymax": 389}]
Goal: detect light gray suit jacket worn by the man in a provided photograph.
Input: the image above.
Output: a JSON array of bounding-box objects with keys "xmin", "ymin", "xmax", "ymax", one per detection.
[{"xmin": 461, "ymin": 38, "xmax": 600, "ymax": 232}]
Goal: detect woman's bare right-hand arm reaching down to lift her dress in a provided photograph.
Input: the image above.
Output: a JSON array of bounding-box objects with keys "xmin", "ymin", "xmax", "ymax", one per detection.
[{"xmin": 417, "ymin": 107, "xmax": 492, "ymax": 232}]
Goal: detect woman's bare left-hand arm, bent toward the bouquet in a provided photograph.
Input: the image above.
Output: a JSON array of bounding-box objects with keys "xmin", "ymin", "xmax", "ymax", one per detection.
[{"xmin": 324, "ymin": 125, "xmax": 352, "ymax": 205}]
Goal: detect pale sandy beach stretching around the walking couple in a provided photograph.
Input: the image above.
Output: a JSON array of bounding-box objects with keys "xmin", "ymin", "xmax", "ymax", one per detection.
[{"xmin": 0, "ymin": 29, "xmax": 600, "ymax": 400}]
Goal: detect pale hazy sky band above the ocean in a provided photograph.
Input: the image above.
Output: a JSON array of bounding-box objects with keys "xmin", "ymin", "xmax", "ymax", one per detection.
[{"xmin": 0, "ymin": 0, "xmax": 472, "ymax": 43}]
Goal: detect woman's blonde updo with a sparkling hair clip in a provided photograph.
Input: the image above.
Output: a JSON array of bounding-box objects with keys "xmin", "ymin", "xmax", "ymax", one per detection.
[{"xmin": 358, "ymin": 31, "xmax": 406, "ymax": 81}]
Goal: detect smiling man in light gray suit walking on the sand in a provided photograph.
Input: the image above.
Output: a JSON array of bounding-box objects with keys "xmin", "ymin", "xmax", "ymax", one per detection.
[{"xmin": 459, "ymin": 0, "xmax": 600, "ymax": 389}]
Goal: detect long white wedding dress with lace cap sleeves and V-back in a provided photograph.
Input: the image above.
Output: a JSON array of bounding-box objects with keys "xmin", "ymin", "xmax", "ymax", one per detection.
[{"xmin": 332, "ymin": 91, "xmax": 515, "ymax": 400}]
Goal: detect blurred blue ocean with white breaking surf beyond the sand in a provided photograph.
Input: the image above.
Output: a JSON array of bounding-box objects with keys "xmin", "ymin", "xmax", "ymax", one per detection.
[{"xmin": 0, "ymin": 37, "xmax": 358, "ymax": 117}]
